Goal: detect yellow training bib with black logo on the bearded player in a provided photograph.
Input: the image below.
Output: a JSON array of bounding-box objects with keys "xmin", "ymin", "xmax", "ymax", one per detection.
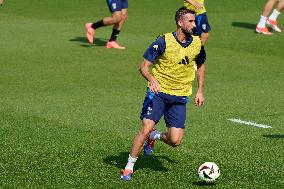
[{"xmin": 152, "ymin": 33, "xmax": 201, "ymax": 96}]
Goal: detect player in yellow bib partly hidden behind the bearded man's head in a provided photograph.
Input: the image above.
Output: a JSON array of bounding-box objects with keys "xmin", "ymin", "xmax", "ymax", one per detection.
[{"xmin": 184, "ymin": 0, "xmax": 211, "ymax": 45}]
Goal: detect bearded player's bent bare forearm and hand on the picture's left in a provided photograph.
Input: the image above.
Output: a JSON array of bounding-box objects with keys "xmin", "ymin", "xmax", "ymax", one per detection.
[{"xmin": 140, "ymin": 59, "xmax": 160, "ymax": 93}]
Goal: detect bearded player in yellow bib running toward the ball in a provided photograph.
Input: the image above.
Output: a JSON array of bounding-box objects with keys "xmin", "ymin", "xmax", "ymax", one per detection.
[{"xmin": 121, "ymin": 7, "xmax": 206, "ymax": 180}]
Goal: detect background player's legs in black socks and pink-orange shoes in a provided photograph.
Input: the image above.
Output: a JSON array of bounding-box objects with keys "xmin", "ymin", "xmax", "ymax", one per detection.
[{"xmin": 85, "ymin": 0, "xmax": 128, "ymax": 49}]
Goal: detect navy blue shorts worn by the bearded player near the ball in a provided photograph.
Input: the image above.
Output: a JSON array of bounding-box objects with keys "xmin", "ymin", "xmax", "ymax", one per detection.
[{"xmin": 140, "ymin": 89, "xmax": 188, "ymax": 128}]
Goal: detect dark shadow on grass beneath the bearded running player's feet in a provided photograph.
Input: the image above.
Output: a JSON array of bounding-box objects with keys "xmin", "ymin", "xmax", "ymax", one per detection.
[{"xmin": 104, "ymin": 152, "xmax": 177, "ymax": 172}]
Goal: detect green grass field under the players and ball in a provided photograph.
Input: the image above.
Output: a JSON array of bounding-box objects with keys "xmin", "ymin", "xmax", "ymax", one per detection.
[{"xmin": 0, "ymin": 0, "xmax": 284, "ymax": 189}]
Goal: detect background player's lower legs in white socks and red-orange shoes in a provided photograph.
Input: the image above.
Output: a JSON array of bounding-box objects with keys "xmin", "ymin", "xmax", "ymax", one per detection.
[{"xmin": 255, "ymin": 0, "xmax": 284, "ymax": 35}]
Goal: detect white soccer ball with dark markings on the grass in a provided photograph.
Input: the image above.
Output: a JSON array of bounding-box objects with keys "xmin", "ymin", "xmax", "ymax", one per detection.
[{"xmin": 198, "ymin": 162, "xmax": 220, "ymax": 183}]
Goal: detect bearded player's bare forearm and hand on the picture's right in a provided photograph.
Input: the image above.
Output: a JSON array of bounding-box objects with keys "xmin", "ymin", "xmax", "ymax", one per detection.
[{"xmin": 195, "ymin": 64, "xmax": 205, "ymax": 106}]
